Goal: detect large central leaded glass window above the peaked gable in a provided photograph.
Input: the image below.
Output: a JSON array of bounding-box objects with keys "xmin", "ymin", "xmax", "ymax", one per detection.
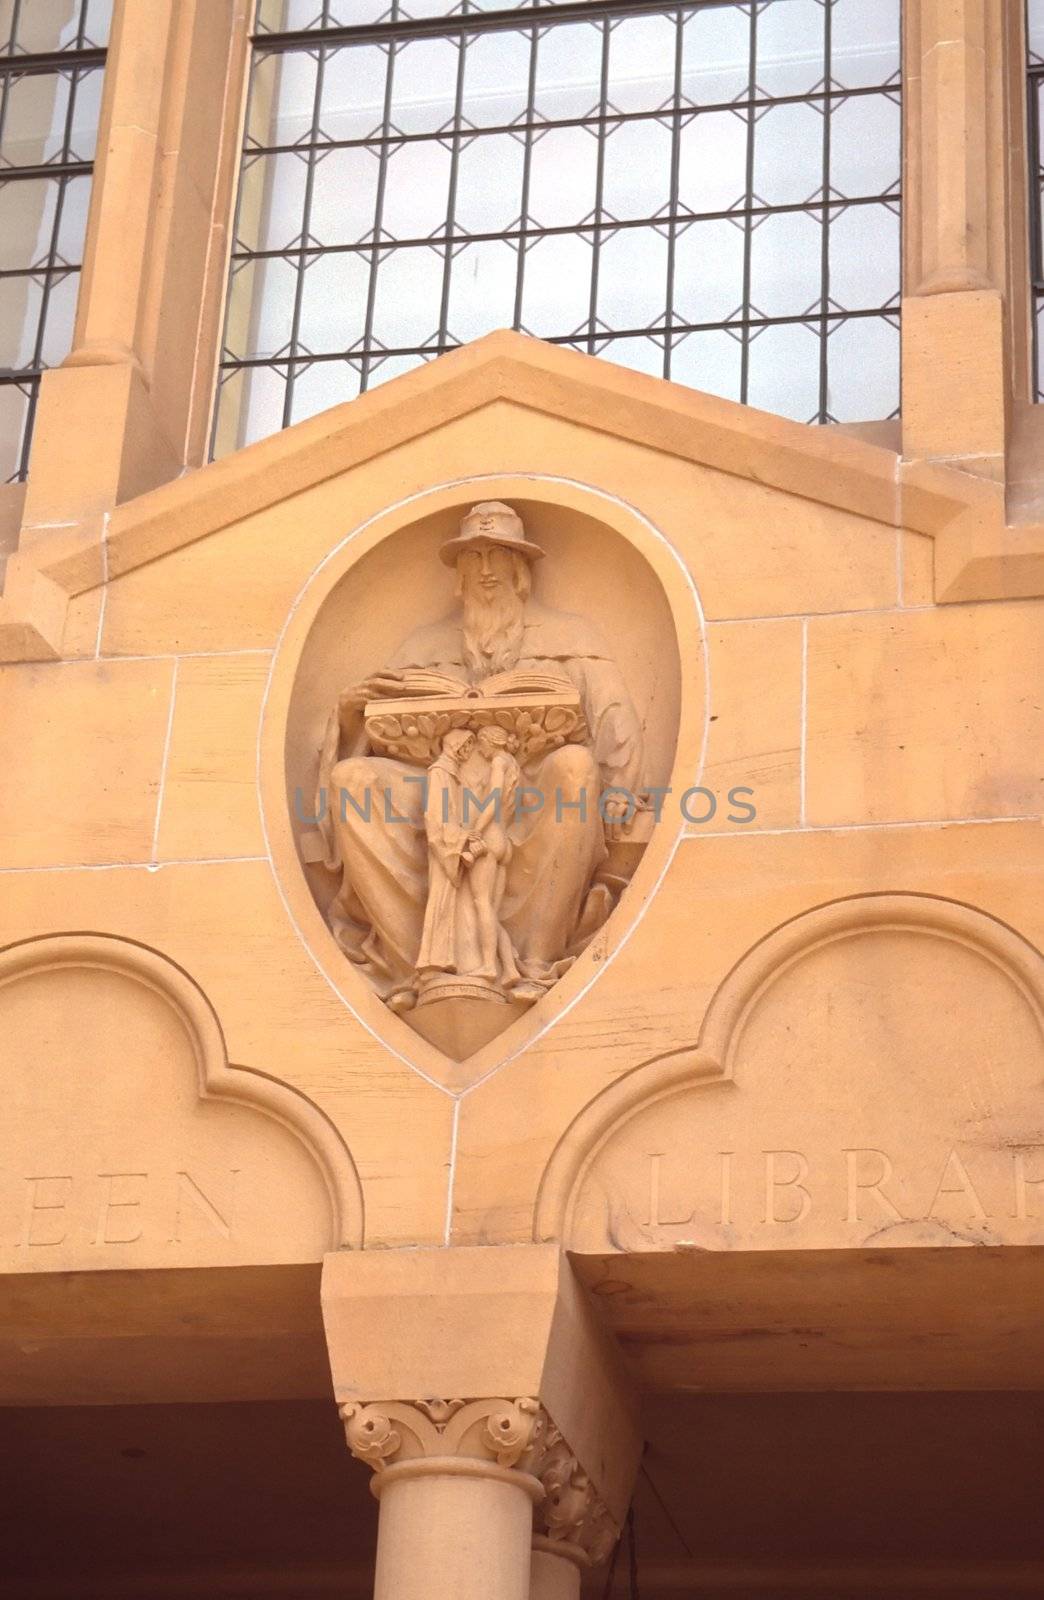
[{"xmin": 216, "ymin": 0, "xmax": 901, "ymax": 454}]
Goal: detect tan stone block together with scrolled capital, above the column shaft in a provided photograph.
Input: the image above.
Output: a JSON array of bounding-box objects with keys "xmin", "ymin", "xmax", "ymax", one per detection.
[{"xmin": 322, "ymin": 1245, "xmax": 642, "ymax": 1538}]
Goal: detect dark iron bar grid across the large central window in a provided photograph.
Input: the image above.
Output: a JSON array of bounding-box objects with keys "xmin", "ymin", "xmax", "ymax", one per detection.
[{"xmin": 215, "ymin": 0, "xmax": 901, "ymax": 454}]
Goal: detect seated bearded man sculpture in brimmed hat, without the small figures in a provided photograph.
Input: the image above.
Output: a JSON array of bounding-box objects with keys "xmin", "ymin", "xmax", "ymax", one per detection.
[{"xmin": 317, "ymin": 502, "xmax": 642, "ymax": 1011}]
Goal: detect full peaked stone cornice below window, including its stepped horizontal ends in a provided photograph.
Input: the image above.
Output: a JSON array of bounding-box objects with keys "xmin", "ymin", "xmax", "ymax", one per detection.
[{"xmin": 0, "ymin": 331, "xmax": 1044, "ymax": 661}]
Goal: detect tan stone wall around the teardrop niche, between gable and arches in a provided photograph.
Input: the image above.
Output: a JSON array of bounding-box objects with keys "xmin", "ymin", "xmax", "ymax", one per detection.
[{"xmin": 0, "ymin": 336, "xmax": 1044, "ymax": 1261}]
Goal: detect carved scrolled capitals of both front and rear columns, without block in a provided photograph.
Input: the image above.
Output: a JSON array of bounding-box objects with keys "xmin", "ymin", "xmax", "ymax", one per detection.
[{"xmin": 338, "ymin": 1397, "xmax": 620, "ymax": 1566}]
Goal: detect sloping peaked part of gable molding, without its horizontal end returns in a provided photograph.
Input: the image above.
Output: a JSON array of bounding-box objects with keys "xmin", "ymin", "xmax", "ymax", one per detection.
[{"xmin": 30, "ymin": 330, "xmax": 958, "ymax": 595}]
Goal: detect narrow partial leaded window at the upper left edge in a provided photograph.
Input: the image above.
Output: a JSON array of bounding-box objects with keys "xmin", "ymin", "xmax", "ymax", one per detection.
[{"xmin": 0, "ymin": 0, "xmax": 112, "ymax": 483}]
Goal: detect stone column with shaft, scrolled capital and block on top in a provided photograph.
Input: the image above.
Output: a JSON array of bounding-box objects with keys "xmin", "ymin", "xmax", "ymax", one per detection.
[{"xmin": 322, "ymin": 1245, "xmax": 640, "ymax": 1600}]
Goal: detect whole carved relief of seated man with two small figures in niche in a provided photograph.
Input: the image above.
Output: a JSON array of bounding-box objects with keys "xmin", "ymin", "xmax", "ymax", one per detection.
[{"xmin": 291, "ymin": 501, "xmax": 677, "ymax": 1058}]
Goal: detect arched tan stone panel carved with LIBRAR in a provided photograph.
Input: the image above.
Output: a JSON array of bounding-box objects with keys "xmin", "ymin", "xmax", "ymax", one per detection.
[{"xmin": 535, "ymin": 894, "xmax": 1044, "ymax": 1253}]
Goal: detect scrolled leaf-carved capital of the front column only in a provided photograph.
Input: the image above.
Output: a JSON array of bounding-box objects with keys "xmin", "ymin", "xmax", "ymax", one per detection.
[{"xmin": 339, "ymin": 1398, "xmax": 549, "ymax": 1499}]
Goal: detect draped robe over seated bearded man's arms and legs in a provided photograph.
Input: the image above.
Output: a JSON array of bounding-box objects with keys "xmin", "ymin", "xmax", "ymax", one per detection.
[{"xmin": 317, "ymin": 602, "xmax": 642, "ymax": 998}]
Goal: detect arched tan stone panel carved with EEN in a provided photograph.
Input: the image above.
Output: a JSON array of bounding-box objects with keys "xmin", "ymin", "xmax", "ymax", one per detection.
[{"xmin": 0, "ymin": 934, "xmax": 362, "ymax": 1272}]
